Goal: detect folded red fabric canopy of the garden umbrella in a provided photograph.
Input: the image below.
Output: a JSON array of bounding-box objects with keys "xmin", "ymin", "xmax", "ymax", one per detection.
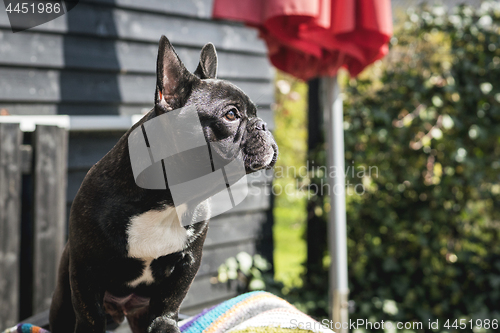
[{"xmin": 213, "ymin": 0, "xmax": 392, "ymax": 80}]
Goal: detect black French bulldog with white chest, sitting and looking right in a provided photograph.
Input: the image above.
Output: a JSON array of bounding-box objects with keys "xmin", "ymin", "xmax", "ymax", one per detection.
[{"xmin": 50, "ymin": 36, "xmax": 278, "ymax": 333}]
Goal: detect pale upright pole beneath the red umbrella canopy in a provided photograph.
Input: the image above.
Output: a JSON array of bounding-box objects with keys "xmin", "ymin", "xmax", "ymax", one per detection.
[{"xmin": 322, "ymin": 76, "xmax": 349, "ymax": 333}]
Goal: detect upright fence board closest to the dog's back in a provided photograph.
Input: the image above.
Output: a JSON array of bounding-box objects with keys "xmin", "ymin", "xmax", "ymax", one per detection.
[{"xmin": 33, "ymin": 126, "xmax": 68, "ymax": 313}]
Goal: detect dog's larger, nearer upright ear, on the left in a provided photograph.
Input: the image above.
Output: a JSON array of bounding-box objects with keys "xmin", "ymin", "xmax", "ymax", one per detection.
[{"xmin": 155, "ymin": 36, "xmax": 197, "ymax": 114}]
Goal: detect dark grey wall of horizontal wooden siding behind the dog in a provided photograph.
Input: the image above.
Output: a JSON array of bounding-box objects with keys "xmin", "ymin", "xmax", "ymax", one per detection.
[{"xmin": 0, "ymin": 0, "xmax": 274, "ymax": 314}]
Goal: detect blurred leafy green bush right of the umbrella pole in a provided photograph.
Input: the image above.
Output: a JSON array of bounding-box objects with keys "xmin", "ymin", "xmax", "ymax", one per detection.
[{"xmin": 345, "ymin": 2, "xmax": 500, "ymax": 332}]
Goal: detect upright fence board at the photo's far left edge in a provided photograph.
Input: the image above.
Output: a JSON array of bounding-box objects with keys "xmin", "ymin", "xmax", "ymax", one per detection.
[{"xmin": 0, "ymin": 124, "xmax": 22, "ymax": 328}]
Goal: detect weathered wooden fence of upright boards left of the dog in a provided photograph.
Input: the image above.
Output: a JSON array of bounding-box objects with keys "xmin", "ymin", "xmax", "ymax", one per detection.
[{"xmin": 0, "ymin": 123, "xmax": 68, "ymax": 329}]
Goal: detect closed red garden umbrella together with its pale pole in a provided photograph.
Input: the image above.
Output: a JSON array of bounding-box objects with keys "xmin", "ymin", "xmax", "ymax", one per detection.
[{"xmin": 213, "ymin": 0, "xmax": 392, "ymax": 333}]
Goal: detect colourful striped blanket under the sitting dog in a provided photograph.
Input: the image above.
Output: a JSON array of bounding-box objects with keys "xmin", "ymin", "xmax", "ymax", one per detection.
[{"xmin": 4, "ymin": 291, "xmax": 333, "ymax": 333}]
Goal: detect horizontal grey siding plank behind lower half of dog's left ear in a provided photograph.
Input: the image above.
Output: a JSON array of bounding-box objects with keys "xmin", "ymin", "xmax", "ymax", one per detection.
[{"xmin": 0, "ymin": 67, "xmax": 274, "ymax": 105}]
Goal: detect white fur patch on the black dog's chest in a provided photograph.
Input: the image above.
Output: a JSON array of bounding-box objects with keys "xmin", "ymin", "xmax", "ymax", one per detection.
[{"xmin": 127, "ymin": 207, "xmax": 188, "ymax": 287}]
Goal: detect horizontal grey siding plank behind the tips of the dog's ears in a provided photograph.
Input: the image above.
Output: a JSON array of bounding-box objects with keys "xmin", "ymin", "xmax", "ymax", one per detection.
[{"xmin": 0, "ymin": 31, "xmax": 272, "ymax": 79}]
